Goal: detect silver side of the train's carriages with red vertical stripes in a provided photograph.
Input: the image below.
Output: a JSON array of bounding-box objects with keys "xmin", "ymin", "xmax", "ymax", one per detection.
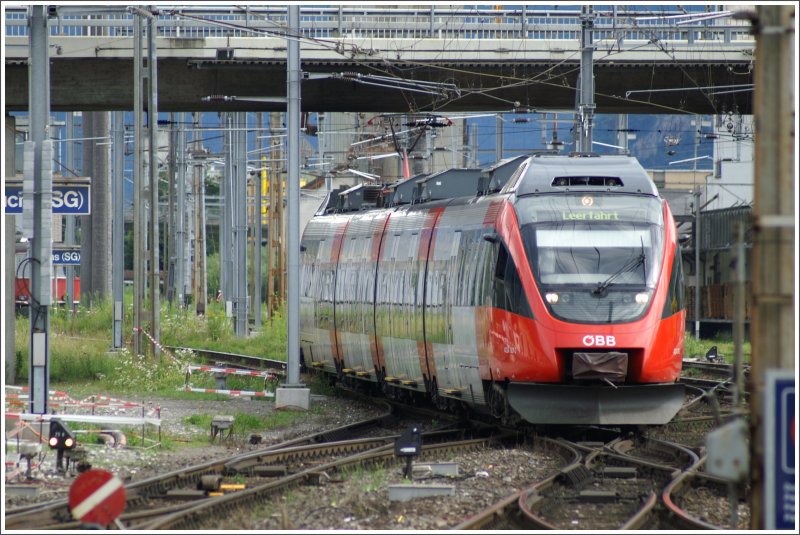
[{"xmin": 301, "ymin": 199, "xmax": 500, "ymax": 404}]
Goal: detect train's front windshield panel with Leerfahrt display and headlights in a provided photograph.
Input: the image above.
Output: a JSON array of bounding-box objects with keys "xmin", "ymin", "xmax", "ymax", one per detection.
[{"xmin": 515, "ymin": 193, "xmax": 664, "ymax": 323}]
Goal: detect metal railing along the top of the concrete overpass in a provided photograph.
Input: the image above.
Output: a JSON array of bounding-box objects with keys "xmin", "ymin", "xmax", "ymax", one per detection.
[{"xmin": 5, "ymin": 6, "xmax": 753, "ymax": 46}]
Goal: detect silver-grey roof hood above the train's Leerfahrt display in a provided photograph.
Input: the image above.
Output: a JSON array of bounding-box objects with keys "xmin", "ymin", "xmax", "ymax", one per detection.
[{"xmin": 504, "ymin": 154, "xmax": 659, "ymax": 197}]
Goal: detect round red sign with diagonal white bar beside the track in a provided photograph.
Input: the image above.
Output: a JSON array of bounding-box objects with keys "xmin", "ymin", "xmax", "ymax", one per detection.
[{"xmin": 68, "ymin": 469, "xmax": 125, "ymax": 526}]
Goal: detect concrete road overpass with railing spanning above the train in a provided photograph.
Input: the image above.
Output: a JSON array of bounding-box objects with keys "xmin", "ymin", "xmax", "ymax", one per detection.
[{"xmin": 4, "ymin": 5, "xmax": 755, "ymax": 114}]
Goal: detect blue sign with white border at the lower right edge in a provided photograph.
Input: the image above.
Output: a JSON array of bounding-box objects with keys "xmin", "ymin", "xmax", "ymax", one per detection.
[{"xmin": 764, "ymin": 369, "xmax": 797, "ymax": 531}]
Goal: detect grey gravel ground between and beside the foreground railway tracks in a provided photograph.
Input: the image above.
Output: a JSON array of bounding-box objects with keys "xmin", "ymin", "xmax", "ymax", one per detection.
[{"xmin": 4, "ymin": 386, "xmax": 748, "ymax": 531}]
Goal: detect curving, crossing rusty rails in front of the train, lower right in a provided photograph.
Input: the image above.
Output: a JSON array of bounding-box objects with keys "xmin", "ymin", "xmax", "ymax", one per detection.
[{"xmin": 454, "ymin": 438, "xmax": 740, "ymax": 530}]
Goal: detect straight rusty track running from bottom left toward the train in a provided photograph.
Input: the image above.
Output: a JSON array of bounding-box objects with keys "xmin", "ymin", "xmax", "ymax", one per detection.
[{"xmin": 6, "ymin": 399, "xmax": 516, "ymax": 530}]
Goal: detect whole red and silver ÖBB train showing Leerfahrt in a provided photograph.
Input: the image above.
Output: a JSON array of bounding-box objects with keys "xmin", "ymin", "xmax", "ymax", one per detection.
[{"xmin": 300, "ymin": 155, "xmax": 685, "ymax": 425}]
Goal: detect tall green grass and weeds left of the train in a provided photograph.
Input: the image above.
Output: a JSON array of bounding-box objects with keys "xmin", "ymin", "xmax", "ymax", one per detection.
[{"xmin": 14, "ymin": 298, "xmax": 287, "ymax": 390}]
